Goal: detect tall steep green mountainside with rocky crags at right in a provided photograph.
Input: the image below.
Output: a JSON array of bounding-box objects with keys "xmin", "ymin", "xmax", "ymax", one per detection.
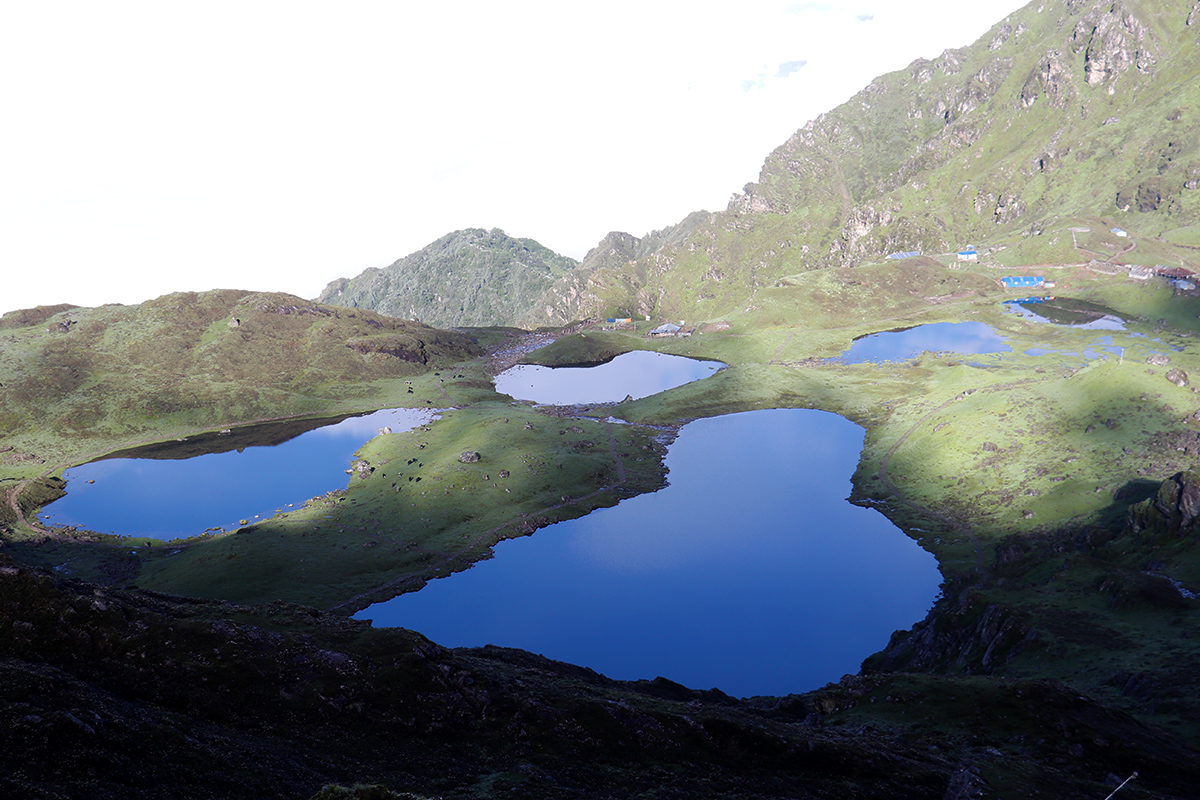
[{"xmin": 535, "ymin": 0, "xmax": 1200, "ymax": 324}]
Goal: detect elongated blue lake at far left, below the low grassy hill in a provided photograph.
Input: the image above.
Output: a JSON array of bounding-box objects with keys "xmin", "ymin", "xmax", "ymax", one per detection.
[{"xmin": 40, "ymin": 409, "xmax": 433, "ymax": 539}]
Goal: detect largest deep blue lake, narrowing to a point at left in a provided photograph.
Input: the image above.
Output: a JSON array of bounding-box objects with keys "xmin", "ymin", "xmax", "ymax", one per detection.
[{"xmin": 356, "ymin": 410, "xmax": 941, "ymax": 696}]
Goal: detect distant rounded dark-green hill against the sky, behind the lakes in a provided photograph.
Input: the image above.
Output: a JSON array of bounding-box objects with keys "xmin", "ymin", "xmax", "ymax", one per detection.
[{"xmin": 318, "ymin": 228, "xmax": 577, "ymax": 327}]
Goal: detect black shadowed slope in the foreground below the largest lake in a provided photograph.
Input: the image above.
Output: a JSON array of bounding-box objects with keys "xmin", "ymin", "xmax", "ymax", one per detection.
[{"xmin": 7, "ymin": 557, "xmax": 1200, "ymax": 799}]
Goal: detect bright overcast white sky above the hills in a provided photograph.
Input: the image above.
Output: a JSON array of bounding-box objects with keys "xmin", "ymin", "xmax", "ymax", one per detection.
[{"xmin": 0, "ymin": 0, "xmax": 1024, "ymax": 312}]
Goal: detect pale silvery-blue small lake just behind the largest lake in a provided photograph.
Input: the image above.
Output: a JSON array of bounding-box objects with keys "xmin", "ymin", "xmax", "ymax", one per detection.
[{"xmin": 496, "ymin": 350, "xmax": 726, "ymax": 405}]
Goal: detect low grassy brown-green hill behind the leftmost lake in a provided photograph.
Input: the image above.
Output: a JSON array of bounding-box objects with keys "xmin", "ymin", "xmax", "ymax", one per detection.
[{"xmin": 0, "ymin": 290, "xmax": 480, "ymax": 475}]
